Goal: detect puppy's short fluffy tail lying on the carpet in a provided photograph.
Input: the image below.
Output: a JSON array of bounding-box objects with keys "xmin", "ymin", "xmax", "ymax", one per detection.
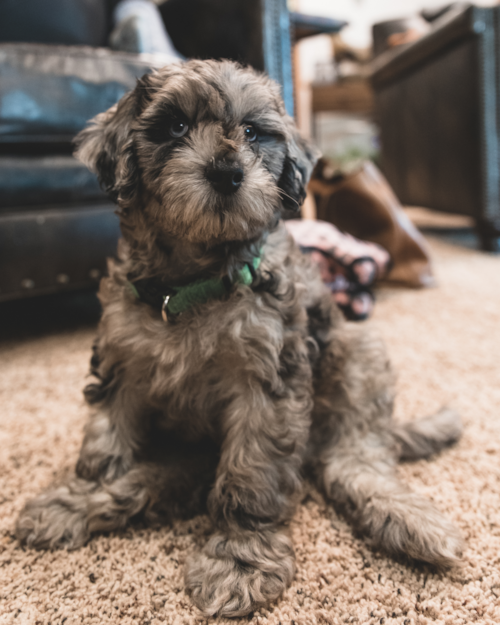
[{"xmin": 391, "ymin": 408, "xmax": 463, "ymax": 461}]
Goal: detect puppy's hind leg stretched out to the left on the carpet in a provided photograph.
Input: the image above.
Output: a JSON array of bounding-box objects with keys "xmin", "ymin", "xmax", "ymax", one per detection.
[{"xmin": 16, "ymin": 433, "xmax": 217, "ymax": 549}]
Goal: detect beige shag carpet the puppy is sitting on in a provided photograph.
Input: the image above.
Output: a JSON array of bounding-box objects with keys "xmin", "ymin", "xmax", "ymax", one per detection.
[{"xmin": 0, "ymin": 230, "xmax": 500, "ymax": 625}]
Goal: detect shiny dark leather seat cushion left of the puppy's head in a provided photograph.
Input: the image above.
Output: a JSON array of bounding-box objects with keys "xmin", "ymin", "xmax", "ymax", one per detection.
[{"xmin": 0, "ymin": 43, "xmax": 178, "ymax": 146}]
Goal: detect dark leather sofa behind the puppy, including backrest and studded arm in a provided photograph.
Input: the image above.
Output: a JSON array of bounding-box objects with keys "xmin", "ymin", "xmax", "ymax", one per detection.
[{"xmin": 0, "ymin": 0, "xmax": 293, "ymax": 301}]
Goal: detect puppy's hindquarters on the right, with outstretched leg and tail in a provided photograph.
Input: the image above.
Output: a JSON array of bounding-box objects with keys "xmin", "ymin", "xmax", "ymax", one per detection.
[{"xmin": 310, "ymin": 328, "xmax": 462, "ymax": 567}]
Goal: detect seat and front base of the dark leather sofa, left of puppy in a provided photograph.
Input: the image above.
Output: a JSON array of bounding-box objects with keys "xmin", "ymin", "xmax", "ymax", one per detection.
[{"xmin": 0, "ymin": 43, "xmax": 177, "ymax": 300}]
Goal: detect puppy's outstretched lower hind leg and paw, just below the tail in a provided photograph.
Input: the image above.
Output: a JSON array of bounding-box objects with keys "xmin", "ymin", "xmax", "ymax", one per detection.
[{"xmin": 319, "ymin": 435, "xmax": 462, "ymax": 567}]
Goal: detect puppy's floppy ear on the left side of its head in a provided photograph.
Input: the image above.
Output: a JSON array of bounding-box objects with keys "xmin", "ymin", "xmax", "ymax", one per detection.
[{"xmin": 74, "ymin": 74, "xmax": 153, "ymax": 205}]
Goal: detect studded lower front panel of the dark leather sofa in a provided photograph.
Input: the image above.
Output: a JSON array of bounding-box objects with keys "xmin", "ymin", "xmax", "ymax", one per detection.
[{"xmin": 0, "ymin": 202, "xmax": 120, "ymax": 302}]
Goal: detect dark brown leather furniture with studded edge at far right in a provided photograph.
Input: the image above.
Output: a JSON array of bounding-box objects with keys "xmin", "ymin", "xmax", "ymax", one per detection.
[{"xmin": 372, "ymin": 5, "xmax": 500, "ymax": 251}]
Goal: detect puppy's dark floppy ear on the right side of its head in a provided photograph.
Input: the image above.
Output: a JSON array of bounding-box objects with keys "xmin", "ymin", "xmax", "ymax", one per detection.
[{"xmin": 278, "ymin": 118, "xmax": 321, "ymax": 213}]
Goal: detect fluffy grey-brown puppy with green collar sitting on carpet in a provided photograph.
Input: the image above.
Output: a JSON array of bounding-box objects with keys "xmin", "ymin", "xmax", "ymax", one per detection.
[{"xmin": 17, "ymin": 61, "xmax": 461, "ymax": 616}]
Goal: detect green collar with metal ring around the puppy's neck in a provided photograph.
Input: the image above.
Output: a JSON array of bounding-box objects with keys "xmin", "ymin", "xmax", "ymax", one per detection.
[{"xmin": 127, "ymin": 256, "xmax": 261, "ymax": 321}]
